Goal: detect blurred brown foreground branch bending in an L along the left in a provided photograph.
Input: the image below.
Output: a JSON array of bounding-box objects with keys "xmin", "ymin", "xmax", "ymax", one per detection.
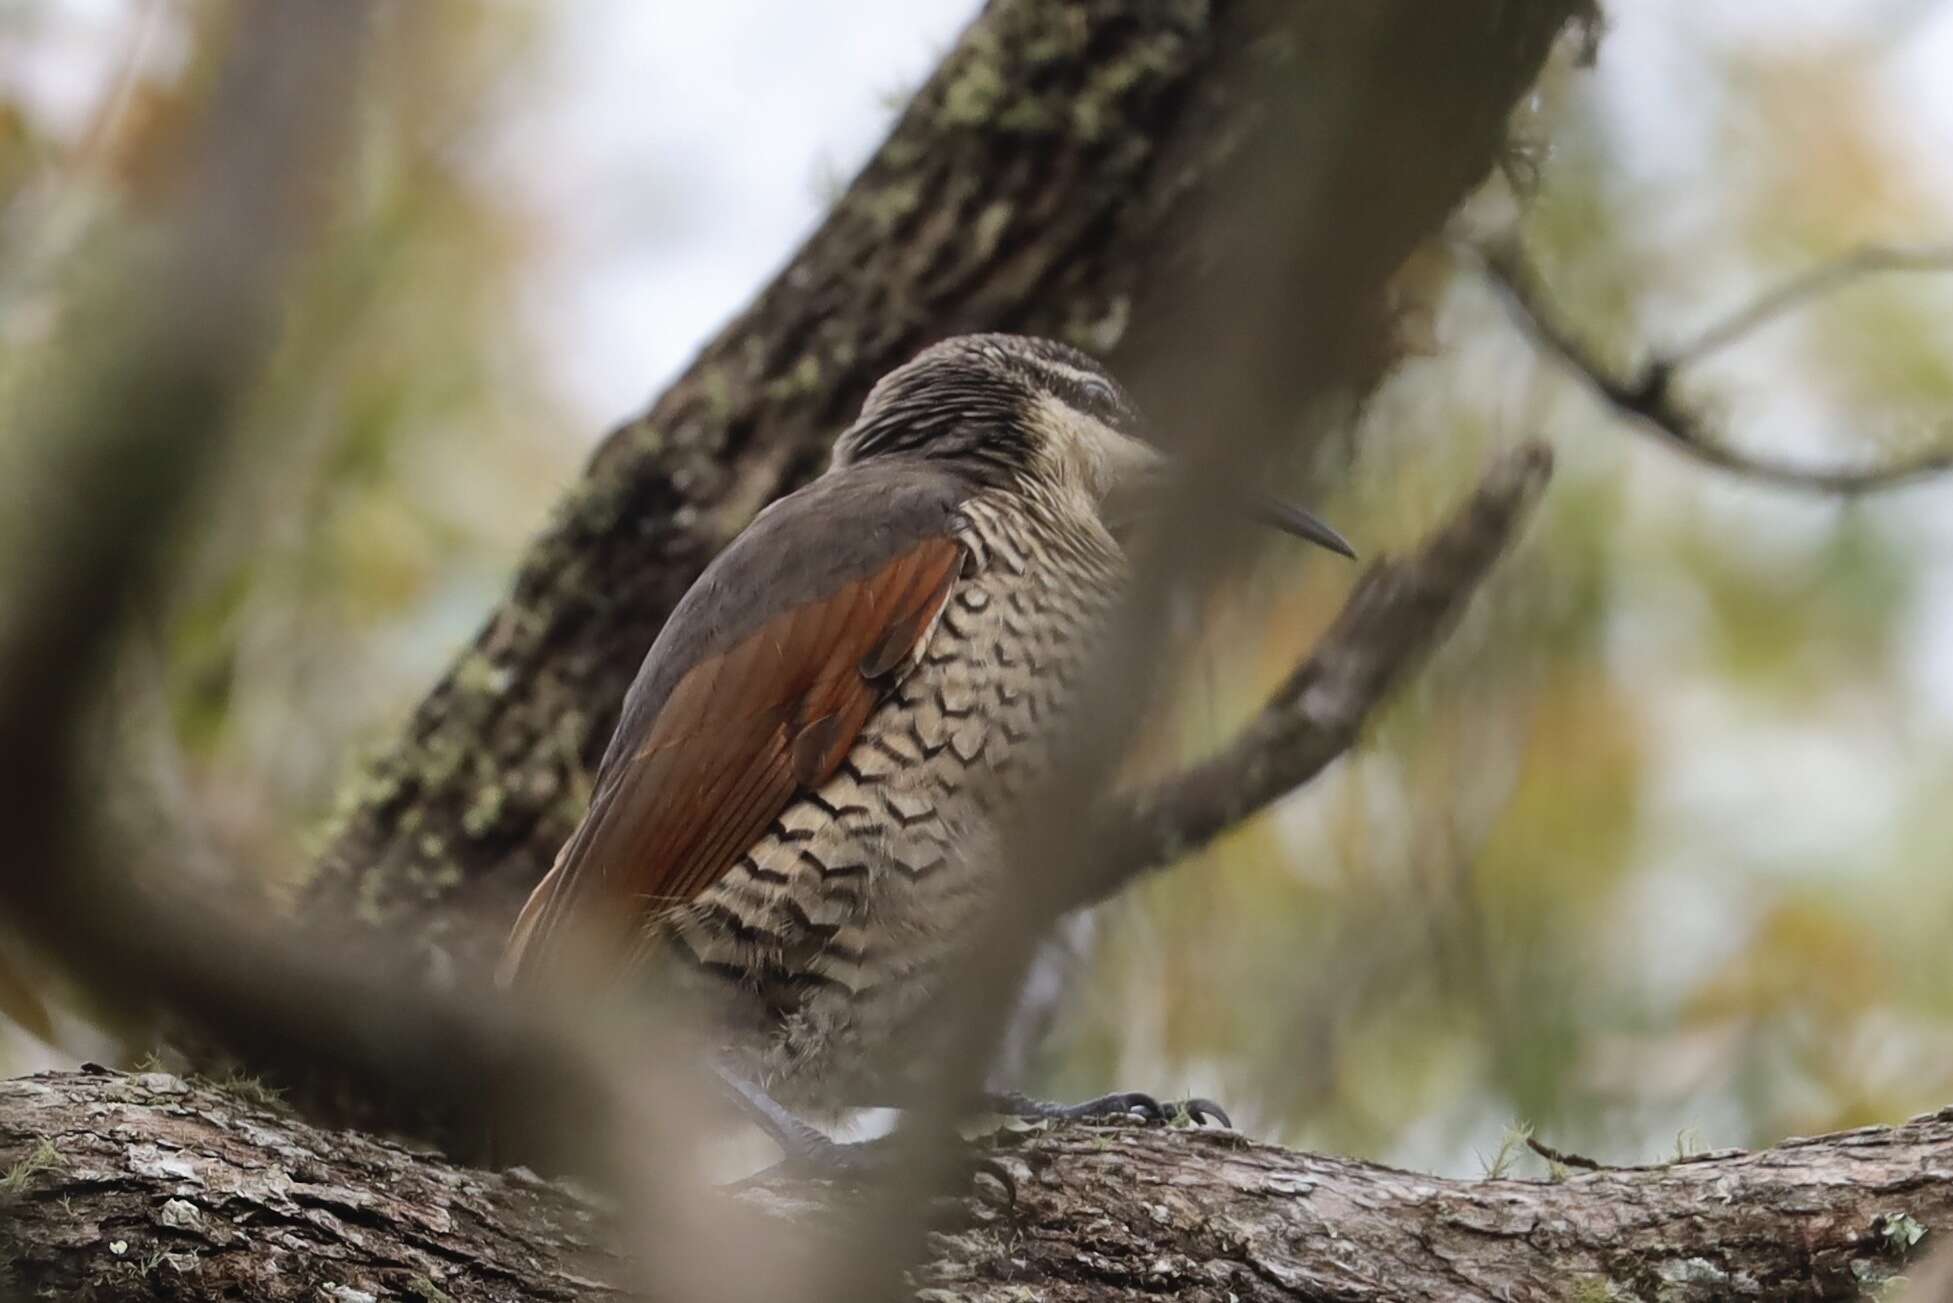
[{"xmin": 0, "ymin": 12, "xmax": 792, "ymax": 1299}]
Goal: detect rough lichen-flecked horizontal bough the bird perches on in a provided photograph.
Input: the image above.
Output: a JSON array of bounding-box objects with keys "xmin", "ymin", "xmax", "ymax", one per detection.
[{"xmin": 0, "ymin": 1071, "xmax": 1953, "ymax": 1303}]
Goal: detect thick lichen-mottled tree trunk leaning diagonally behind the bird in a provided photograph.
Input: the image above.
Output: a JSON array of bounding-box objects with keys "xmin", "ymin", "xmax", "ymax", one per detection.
[{"xmin": 305, "ymin": 0, "xmax": 1590, "ymax": 973}]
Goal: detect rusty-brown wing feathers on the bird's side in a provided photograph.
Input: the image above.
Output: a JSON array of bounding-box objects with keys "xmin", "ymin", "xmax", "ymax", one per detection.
[{"xmin": 502, "ymin": 537, "xmax": 963, "ymax": 981}]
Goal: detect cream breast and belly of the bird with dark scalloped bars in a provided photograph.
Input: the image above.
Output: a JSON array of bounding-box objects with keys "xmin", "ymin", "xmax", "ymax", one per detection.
[{"xmin": 662, "ymin": 488, "xmax": 1125, "ymax": 1114}]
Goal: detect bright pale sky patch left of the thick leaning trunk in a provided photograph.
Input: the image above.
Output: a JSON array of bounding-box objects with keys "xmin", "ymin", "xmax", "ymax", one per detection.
[{"xmin": 502, "ymin": 0, "xmax": 978, "ymax": 427}]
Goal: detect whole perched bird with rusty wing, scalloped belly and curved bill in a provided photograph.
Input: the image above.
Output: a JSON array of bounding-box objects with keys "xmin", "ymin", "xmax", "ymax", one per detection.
[{"xmin": 498, "ymin": 334, "xmax": 1355, "ymax": 1155}]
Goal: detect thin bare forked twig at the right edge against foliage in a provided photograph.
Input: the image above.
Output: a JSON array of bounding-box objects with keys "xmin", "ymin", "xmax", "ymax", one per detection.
[{"xmin": 1473, "ymin": 242, "xmax": 1953, "ymax": 496}]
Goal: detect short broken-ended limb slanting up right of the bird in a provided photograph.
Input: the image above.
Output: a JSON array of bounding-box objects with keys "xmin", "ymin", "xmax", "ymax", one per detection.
[{"xmin": 1078, "ymin": 443, "xmax": 1553, "ymax": 904}]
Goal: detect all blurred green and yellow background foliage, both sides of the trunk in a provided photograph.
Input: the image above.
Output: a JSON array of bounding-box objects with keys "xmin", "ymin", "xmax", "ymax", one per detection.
[{"xmin": 0, "ymin": 0, "xmax": 1953, "ymax": 1172}]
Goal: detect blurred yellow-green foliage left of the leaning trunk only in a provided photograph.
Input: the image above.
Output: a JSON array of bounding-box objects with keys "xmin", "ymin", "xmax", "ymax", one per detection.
[{"xmin": 0, "ymin": 0, "xmax": 588, "ymax": 918}]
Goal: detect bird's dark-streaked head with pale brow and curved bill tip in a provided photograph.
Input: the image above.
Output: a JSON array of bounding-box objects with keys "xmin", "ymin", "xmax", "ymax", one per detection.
[{"xmin": 834, "ymin": 334, "xmax": 1355, "ymax": 557}]
